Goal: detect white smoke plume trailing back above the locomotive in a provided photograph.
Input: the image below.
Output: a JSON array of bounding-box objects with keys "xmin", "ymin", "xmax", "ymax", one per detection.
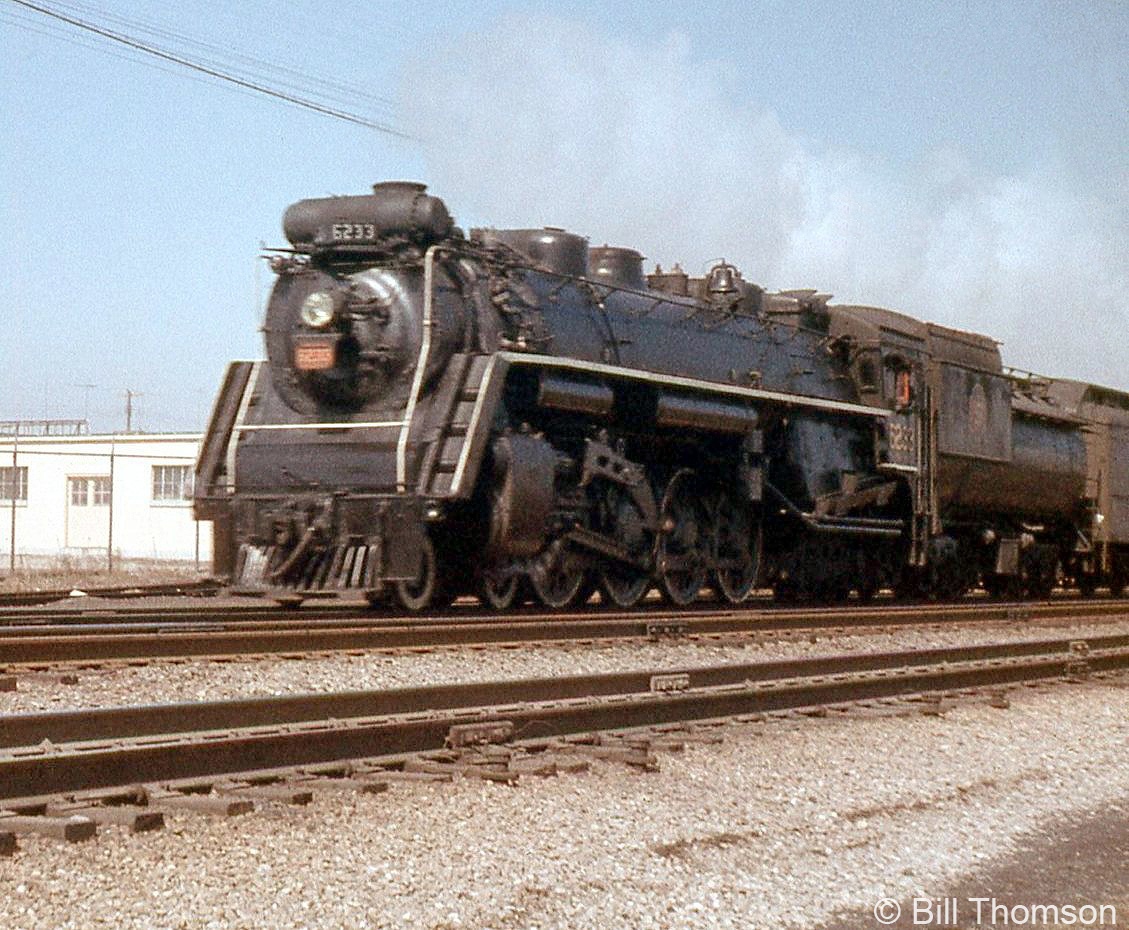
[{"xmin": 402, "ymin": 16, "xmax": 1129, "ymax": 388}]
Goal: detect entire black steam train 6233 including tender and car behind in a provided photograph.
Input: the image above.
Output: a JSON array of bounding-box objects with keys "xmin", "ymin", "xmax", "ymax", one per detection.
[{"xmin": 195, "ymin": 182, "xmax": 1129, "ymax": 611}]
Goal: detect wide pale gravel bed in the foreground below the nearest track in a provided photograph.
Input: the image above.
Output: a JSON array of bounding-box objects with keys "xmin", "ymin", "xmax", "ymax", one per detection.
[{"xmin": 0, "ymin": 677, "xmax": 1129, "ymax": 930}]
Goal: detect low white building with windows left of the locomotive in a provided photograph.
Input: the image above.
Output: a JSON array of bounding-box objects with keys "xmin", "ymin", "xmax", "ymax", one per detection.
[{"xmin": 0, "ymin": 433, "xmax": 211, "ymax": 569}]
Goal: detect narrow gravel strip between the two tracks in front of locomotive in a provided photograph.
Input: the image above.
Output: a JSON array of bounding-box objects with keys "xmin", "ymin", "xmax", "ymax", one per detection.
[{"xmin": 0, "ymin": 621, "xmax": 1129, "ymax": 713}]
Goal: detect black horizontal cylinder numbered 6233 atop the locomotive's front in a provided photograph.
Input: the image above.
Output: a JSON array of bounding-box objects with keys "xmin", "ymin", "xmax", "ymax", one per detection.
[{"xmin": 282, "ymin": 181, "xmax": 453, "ymax": 252}]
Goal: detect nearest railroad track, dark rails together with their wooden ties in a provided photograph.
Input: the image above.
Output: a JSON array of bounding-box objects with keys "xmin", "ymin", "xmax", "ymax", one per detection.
[{"xmin": 0, "ymin": 634, "xmax": 1129, "ymax": 853}]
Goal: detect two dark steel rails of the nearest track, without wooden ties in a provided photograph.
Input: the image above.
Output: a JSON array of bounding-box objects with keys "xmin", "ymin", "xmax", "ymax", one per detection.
[{"xmin": 0, "ymin": 635, "xmax": 1129, "ymax": 801}]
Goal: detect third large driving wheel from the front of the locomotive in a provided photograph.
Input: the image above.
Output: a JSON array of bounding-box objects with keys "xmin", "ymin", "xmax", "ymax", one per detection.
[{"xmin": 656, "ymin": 471, "xmax": 711, "ymax": 607}]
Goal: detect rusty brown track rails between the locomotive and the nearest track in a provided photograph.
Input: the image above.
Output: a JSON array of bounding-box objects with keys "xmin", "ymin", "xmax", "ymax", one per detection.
[{"xmin": 0, "ymin": 600, "xmax": 1129, "ymax": 676}]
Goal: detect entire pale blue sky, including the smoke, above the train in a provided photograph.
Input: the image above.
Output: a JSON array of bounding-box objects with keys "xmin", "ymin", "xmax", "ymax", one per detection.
[{"xmin": 0, "ymin": 0, "xmax": 1129, "ymax": 430}]
